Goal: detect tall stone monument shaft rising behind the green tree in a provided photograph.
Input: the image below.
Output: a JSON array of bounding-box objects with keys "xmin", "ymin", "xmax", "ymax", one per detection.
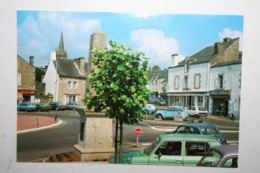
[{"xmin": 87, "ymin": 31, "xmax": 107, "ymax": 89}]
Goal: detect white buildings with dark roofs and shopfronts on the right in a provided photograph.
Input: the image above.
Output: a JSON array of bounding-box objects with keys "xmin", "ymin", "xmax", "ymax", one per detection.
[{"xmin": 167, "ymin": 38, "xmax": 242, "ymax": 116}]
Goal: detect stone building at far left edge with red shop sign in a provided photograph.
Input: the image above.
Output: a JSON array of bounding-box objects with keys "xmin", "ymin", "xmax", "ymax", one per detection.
[{"xmin": 17, "ymin": 55, "xmax": 35, "ymax": 103}]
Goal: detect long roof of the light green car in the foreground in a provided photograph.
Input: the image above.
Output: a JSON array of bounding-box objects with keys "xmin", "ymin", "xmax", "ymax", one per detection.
[{"xmin": 159, "ymin": 133, "xmax": 217, "ymax": 141}]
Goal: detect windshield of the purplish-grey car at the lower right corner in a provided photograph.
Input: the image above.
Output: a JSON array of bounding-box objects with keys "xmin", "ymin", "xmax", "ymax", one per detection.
[{"xmin": 199, "ymin": 150, "xmax": 222, "ymax": 167}]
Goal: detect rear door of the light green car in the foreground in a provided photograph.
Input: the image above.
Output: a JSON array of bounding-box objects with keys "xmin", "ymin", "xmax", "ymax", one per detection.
[{"xmin": 183, "ymin": 141, "xmax": 210, "ymax": 166}]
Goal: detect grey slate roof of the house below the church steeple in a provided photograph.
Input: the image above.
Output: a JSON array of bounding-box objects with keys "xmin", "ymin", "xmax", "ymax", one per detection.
[{"xmin": 53, "ymin": 59, "xmax": 87, "ymax": 78}]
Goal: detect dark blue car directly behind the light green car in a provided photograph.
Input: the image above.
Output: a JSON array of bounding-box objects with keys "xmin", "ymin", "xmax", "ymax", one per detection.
[{"xmin": 173, "ymin": 123, "xmax": 227, "ymax": 144}]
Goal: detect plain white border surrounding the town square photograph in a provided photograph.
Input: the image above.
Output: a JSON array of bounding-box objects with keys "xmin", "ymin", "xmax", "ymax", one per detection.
[{"xmin": 0, "ymin": 0, "xmax": 260, "ymax": 173}]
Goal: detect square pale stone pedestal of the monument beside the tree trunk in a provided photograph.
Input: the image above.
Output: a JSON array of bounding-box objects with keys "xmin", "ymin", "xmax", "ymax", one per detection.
[{"xmin": 73, "ymin": 109, "xmax": 114, "ymax": 162}]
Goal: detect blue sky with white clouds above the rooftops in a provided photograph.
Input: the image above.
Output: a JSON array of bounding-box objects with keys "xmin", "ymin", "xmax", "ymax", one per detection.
[{"xmin": 17, "ymin": 11, "xmax": 243, "ymax": 69}]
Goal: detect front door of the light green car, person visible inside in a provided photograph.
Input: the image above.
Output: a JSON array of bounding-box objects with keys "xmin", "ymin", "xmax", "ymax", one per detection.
[{"xmin": 149, "ymin": 141, "xmax": 183, "ymax": 166}]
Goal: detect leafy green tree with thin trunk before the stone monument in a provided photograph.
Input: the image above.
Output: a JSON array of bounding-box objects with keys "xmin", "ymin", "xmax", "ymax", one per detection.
[{"xmin": 84, "ymin": 41, "xmax": 150, "ymax": 163}]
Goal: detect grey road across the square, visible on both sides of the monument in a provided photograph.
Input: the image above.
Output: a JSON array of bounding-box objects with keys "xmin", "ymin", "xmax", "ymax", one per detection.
[{"xmin": 17, "ymin": 111, "xmax": 239, "ymax": 162}]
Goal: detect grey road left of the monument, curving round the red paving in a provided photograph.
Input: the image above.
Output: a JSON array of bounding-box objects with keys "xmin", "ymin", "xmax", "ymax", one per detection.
[{"xmin": 17, "ymin": 112, "xmax": 79, "ymax": 162}]
